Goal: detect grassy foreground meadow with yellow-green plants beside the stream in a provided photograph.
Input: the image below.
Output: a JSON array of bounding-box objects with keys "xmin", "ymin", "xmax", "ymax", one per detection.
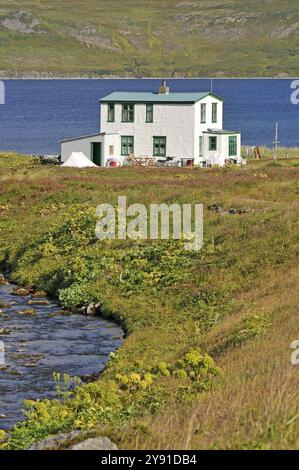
[{"xmin": 0, "ymin": 154, "xmax": 299, "ymax": 449}]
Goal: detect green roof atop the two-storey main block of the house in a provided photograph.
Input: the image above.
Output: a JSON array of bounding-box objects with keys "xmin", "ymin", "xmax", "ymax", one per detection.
[{"xmin": 100, "ymin": 91, "xmax": 223, "ymax": 103}]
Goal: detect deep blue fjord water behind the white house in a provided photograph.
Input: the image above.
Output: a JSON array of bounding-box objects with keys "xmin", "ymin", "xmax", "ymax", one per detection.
[{"xmin": 0, "ymin": 79, "xmax": 299, "ymax": 154}]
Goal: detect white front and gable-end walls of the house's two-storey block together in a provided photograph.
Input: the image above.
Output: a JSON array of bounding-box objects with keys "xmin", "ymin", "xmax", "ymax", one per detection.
[{"xmin": 100, "ymin": 96, "xmax": 223, "ymax": 160}]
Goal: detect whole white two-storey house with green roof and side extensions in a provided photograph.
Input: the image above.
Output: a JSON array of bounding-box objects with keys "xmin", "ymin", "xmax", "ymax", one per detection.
[{"xmin": 61, "ymin": 82, "xmax": 242, "ymax": 166}]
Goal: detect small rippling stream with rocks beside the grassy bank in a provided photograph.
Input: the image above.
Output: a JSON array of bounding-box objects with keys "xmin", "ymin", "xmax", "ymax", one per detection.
[{"xmin": 0, "ymin": 284, "xmax": 123, "ymax": 429}]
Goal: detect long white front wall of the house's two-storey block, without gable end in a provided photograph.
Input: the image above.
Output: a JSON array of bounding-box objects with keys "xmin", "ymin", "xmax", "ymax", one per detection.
[{"xmin": 101, "ymin": 103, "xmax": 195, "ymax": 158}]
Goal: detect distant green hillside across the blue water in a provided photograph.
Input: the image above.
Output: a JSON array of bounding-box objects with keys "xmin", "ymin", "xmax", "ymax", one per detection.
[{"xmin": 0, "ymin": 0, "xmax": 299, "ymax": 77}]
